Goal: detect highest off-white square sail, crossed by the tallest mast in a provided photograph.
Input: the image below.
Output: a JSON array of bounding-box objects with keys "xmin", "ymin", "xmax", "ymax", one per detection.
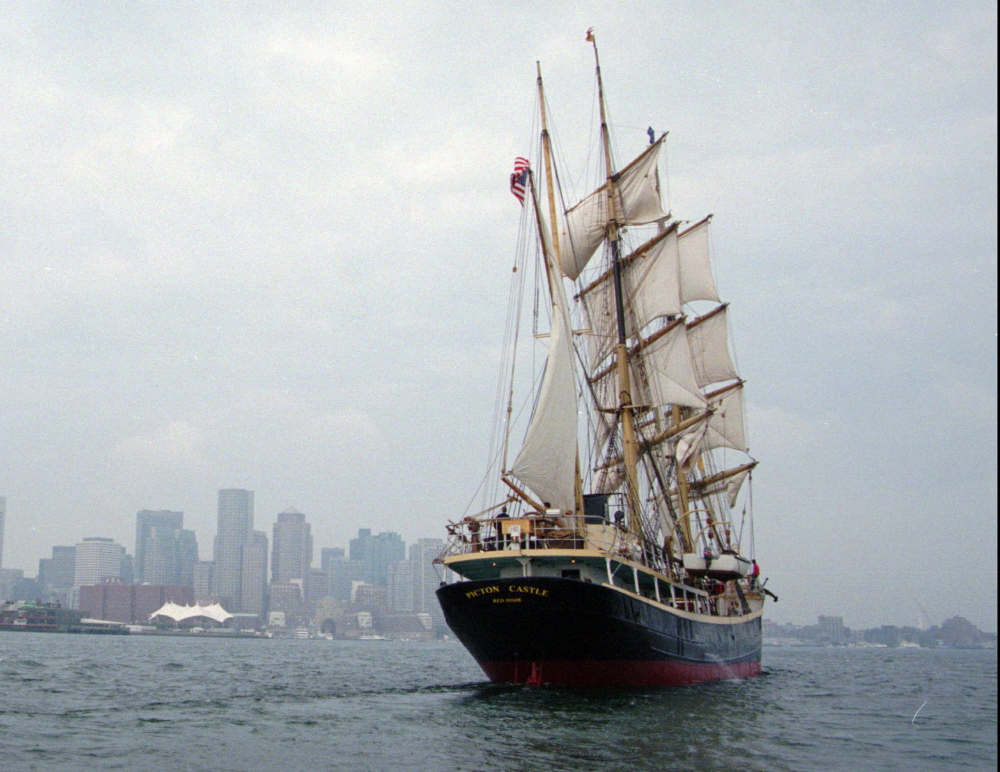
[{"xmin": 559, "ymin": 137, "xmax": 666, "ymax": 280}]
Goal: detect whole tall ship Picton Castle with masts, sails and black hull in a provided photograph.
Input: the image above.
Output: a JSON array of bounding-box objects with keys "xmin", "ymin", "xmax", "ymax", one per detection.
[{"xmin": 437, "ymin": 31, "xmax": 773, "ymax": 686}]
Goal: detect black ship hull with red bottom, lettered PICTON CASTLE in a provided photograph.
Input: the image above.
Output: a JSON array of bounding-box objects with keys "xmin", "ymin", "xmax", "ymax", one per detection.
[{"xmin": 437, "ymin": 577, "xmax": 761, "ymax": 686}]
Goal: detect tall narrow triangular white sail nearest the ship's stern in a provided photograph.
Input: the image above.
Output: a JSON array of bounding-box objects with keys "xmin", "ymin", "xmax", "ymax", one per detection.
[{"xmin": 510, "ymin": 217, "xmax": 578, "ymax": 511}]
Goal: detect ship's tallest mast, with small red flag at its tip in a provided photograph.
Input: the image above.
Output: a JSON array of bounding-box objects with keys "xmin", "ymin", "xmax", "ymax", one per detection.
[{"xmin": 587, "ymin": 30, "xmax": 642, "ymax": 537}]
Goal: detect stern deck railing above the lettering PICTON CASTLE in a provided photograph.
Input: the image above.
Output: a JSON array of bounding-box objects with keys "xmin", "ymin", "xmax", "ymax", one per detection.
[{"xmin": 442, "ymin": 514, "xmax": 584, "ymax": 557}]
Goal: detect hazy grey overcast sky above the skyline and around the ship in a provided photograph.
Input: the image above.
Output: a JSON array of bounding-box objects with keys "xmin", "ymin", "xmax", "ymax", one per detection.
[{"xmin": 0, "ymin": 0, "xmax": 997, "ymax": 630}]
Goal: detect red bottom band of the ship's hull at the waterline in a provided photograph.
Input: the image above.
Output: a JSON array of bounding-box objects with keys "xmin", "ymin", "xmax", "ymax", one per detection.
[{"xmin": 479, "ymin": 660, "xmax": 760, "ymax": 686}]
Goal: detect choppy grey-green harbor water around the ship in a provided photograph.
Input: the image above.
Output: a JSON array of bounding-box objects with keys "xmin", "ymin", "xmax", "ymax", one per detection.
[{"xmin": 0, "ymin": 633, "xmax": 997, "ymax": 772}]
